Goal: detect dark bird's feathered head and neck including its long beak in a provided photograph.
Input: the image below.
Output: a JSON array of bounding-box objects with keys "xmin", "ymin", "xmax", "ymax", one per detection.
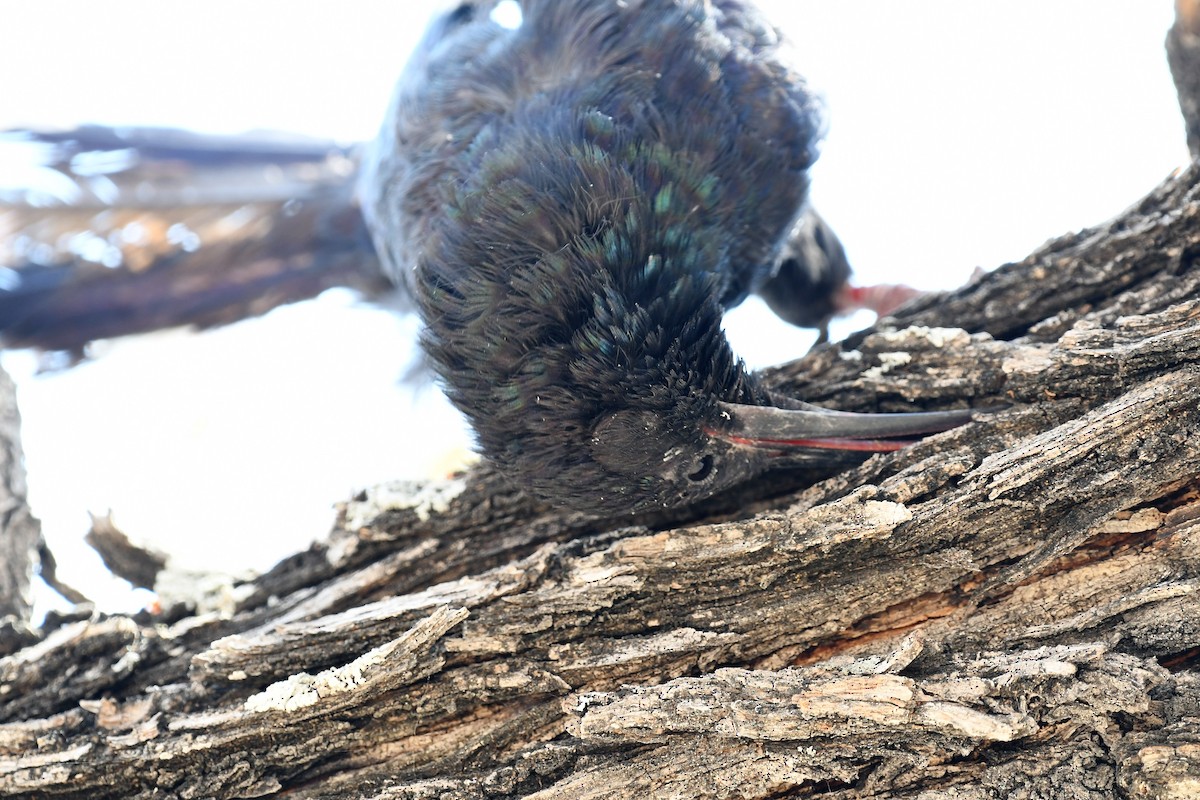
[{"xmin": 426, "ymin": 248, "xmax": 970, "ymax": 515}]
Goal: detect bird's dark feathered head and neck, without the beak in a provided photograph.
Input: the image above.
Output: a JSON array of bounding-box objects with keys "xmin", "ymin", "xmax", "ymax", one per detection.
[{"xmin": 458, "ymin": 261, "xmax": 767, "ymax": 513}]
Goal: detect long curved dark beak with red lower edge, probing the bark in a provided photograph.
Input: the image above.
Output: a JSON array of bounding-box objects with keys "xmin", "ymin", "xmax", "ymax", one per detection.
[{"xmin": 712, "ymin": 403, "xmax": 978, "ymax": 452}]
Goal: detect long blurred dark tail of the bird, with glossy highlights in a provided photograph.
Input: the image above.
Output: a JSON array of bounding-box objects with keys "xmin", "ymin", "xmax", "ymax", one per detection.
[{"xmin": 0, "ymin": 126, "xmax": 389, "ymax": 354}]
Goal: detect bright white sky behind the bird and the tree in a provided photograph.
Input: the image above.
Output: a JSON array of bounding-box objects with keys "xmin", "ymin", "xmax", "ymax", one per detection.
[{"xmin": 0, "ymin": 0, "xmax": 1187, "ymax": 609}]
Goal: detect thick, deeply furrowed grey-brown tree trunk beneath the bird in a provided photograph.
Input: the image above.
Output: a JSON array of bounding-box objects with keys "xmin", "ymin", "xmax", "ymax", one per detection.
[{"xmin": 7, "ymin": 6, "xmax": 1200, "ymax": 800}]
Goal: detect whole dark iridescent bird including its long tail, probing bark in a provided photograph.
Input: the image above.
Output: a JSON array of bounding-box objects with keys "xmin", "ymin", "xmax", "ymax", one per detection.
[{"xmin": 0, "ymin": 0, "xmax": 972, "ymax": 516}]
